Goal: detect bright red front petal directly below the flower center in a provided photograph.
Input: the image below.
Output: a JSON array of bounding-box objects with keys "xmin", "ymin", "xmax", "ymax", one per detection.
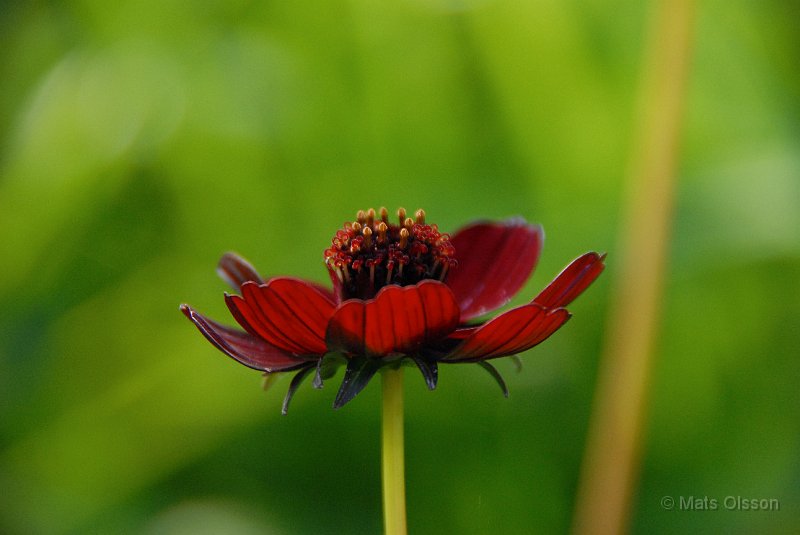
[{"xmin": 326, "ymin": 280, "xmax": 459, "ymax": 357}]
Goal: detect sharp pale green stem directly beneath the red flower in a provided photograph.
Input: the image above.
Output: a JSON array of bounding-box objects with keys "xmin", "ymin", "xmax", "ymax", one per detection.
[{"xmin": 381, "ymin": 368, "xmax": 406, "ymax": 535}]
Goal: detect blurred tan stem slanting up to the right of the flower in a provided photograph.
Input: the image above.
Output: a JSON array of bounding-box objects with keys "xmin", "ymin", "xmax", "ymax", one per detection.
[{"xmin": 573, "ymin": 0, "xmax": 694, "ymax": 535}]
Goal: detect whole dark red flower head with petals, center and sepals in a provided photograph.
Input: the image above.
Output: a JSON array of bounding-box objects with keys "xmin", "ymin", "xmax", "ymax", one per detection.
[{"xmin": 181, "ymin": 208, "xmax": 605, "ymax": 413}]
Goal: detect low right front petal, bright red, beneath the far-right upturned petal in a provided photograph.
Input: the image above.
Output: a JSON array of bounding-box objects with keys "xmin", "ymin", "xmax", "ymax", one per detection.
[{"xmin": 443, "ymin": 303, "xmax": 570, "ymax": 362}]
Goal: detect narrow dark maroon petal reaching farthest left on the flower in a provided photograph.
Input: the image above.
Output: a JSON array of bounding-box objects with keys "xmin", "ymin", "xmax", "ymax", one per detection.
[{"xmin": 181, "ymin": 305, "xmax": 308, "ymax": 372}]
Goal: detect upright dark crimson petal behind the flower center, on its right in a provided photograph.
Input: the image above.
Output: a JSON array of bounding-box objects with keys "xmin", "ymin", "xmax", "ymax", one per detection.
[{"xmin": 447, "ymin": 219, "xmax": 544, "ymax": 321}]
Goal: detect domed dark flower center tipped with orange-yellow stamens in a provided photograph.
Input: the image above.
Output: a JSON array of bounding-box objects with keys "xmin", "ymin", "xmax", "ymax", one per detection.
[{"xmin": 325, "ymin": 208, "xmax": 456, "ymax": 299}]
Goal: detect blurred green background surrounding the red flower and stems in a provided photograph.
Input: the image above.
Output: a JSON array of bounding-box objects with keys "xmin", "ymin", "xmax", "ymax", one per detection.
[{"xmin": 0, "ymin": 0, "xmax": 800, "ymax": 534}]
